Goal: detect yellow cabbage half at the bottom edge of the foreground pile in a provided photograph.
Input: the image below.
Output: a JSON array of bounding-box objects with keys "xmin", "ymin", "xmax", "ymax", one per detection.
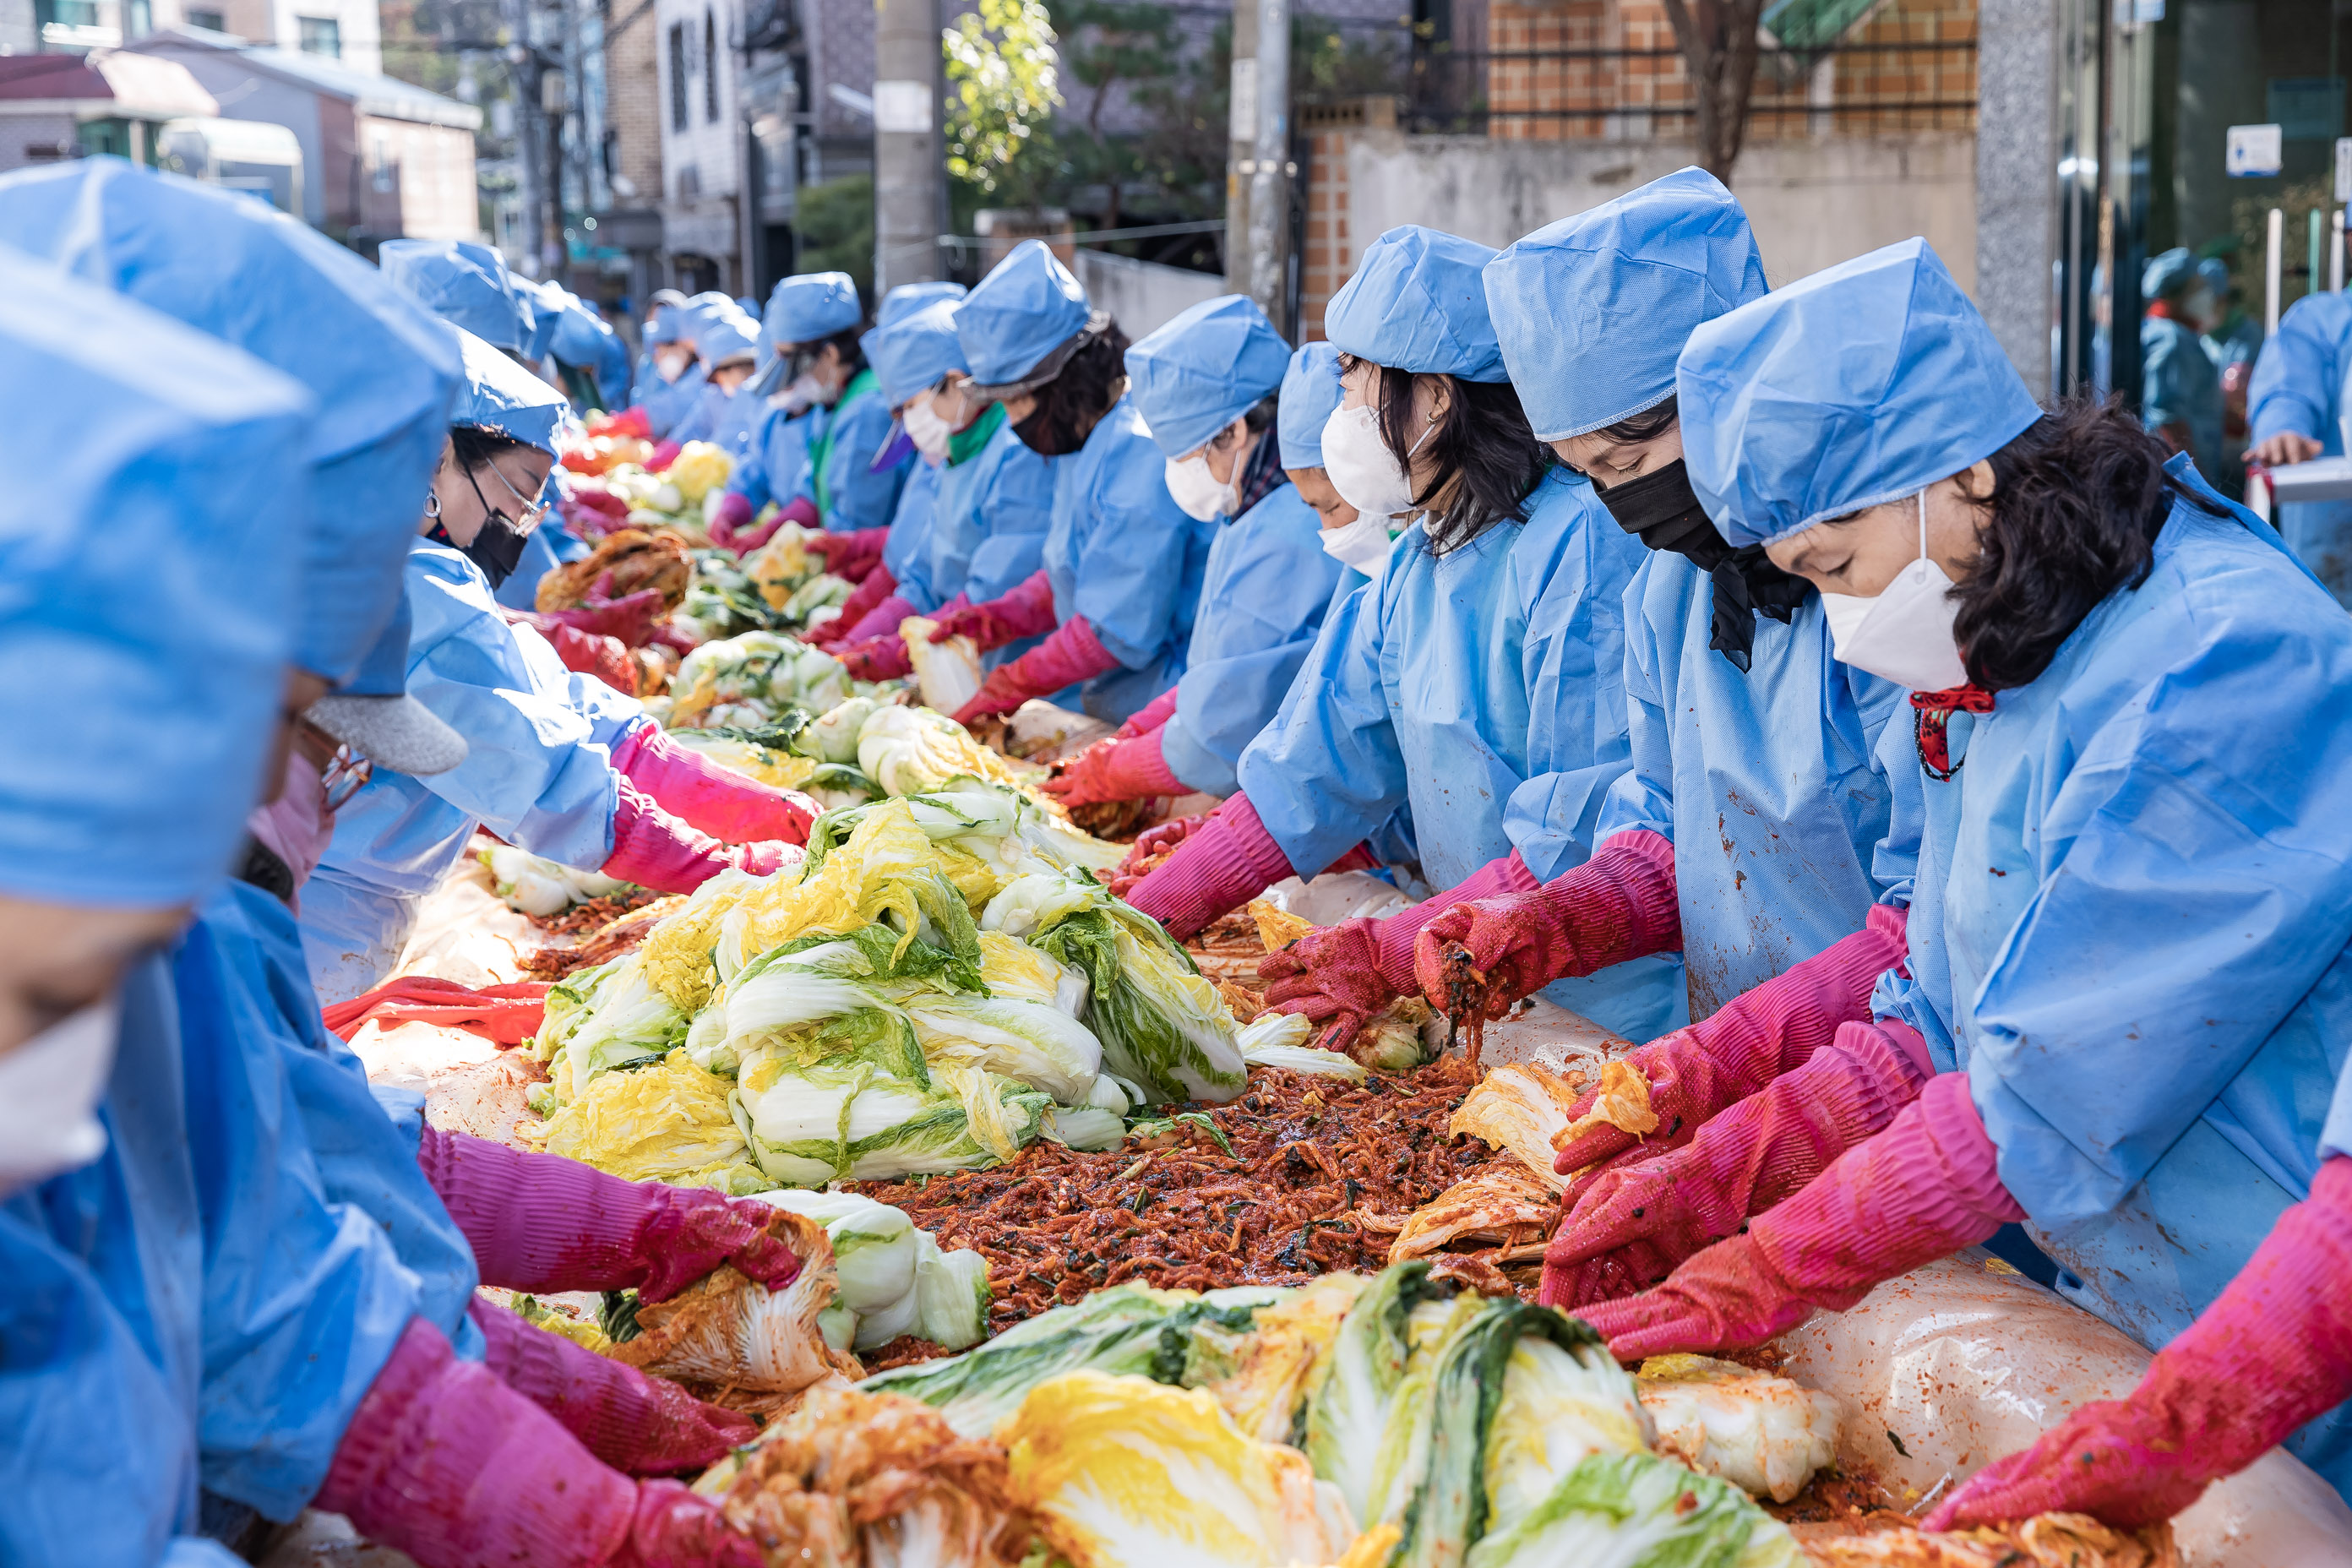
[{"xmin": 1002, "ymin": 1370, "xmax": 1355, "ymax": 1568}]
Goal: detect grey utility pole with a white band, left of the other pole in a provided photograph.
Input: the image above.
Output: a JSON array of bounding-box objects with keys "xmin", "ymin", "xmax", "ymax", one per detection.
[{"xmin": 875, "ymin": 0, "xmax": 948, "ymax": 303}]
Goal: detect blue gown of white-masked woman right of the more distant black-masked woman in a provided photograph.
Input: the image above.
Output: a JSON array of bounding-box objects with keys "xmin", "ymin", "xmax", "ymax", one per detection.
[{"xmin": 1160, "ymin": 482, "xmax": 1343, "ymax": 795}]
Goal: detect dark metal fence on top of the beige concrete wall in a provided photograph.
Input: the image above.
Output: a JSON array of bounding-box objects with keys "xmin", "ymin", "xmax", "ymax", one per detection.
[{"xmin": 1407, "ymin": 38, "xmax": 1976, "ymax": 141}]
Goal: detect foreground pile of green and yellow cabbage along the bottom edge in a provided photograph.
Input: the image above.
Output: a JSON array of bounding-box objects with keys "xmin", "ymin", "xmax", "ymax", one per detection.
[{"xmin": 757, "ymin": 1262, "xmax": 1804, "ymax": 1568}]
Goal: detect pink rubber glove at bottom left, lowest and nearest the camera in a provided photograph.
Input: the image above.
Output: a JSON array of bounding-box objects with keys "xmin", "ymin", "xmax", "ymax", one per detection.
[{"xmin": 313, "ymin": 1319, "xmax": 765, "ymax": 1568}]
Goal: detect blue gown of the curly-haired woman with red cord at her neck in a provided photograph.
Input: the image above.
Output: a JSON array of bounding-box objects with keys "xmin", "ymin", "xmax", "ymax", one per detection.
[{"xmin": 1872, "ymin": 456, "xmax": 2352, "ymax": 1490}]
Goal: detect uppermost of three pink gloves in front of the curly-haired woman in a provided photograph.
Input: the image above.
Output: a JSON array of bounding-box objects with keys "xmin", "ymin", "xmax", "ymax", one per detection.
[{"xmin": 1552, "ymin": 905, "xmax": 1905, "ymax": 1184}]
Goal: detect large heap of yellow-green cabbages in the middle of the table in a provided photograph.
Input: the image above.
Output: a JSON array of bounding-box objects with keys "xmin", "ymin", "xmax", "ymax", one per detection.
[{"xmin": 534, "ymin": 780, "xmax": 1244, "ymax": 1195}]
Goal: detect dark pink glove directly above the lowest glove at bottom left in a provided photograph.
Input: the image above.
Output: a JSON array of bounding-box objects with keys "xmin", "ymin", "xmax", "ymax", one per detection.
[{"xmin": 466, "ymin": 1298, "xmax": 760, "ymax": 1476}]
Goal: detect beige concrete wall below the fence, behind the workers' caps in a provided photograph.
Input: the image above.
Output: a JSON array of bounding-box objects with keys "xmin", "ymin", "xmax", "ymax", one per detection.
[{"xmin": 1317, "ymin": 132, "xmax": 1976, "ymax": 289}]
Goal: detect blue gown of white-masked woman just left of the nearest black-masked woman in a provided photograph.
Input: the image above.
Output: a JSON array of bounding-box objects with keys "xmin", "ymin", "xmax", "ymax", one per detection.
[{"xmin": 1237, "ymin": 468, "xmax": 1684, "ymax": 1039}]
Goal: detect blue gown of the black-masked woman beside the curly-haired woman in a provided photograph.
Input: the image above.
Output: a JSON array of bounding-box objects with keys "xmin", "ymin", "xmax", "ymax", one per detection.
[{"xmin": 1597, "ymin": 550, "xmax": 1919, "ymax": 1018}]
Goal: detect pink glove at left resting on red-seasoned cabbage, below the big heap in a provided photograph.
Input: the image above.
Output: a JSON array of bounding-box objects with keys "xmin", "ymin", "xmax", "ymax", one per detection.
[{"xmin": 416, "ymin": 1126, "xmax": 818, "ymax": 1303}]
